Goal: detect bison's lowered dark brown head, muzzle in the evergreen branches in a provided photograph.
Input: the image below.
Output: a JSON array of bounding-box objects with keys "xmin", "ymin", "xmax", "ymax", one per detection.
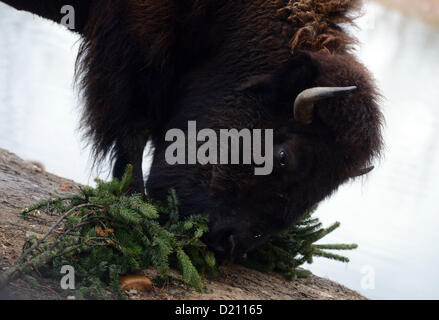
[{"xmin": 147, "ymin": 47, "xmax": 381, "ymax": 257}]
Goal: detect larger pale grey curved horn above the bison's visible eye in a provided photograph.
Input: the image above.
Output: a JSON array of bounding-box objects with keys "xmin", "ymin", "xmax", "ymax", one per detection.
[{"xmin": 294, "ymin": 87, "xmax": 357, "ymax": 124}]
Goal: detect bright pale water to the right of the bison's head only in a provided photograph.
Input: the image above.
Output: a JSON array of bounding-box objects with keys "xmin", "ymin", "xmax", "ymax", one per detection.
[{"xmin": 311, "ymin": 5, "xmax": 439, "ymax": 299}]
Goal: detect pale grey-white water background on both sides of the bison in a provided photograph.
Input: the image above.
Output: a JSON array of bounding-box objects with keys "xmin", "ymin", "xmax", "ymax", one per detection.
[{"xmin": 0, "ymin": 3, "xmax": 439, "ymax": 299}]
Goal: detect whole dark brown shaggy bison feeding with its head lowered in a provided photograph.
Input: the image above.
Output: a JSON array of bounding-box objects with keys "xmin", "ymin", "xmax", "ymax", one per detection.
[{"xmin": 2, "ymin": 0, "xmax": 383, "ymax": 257}]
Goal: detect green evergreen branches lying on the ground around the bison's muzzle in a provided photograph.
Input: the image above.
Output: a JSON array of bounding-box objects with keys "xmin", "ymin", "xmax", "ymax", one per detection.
[{"xmin": 0, "ymin": 166, "xmax": 357, "ymax": 299}]
